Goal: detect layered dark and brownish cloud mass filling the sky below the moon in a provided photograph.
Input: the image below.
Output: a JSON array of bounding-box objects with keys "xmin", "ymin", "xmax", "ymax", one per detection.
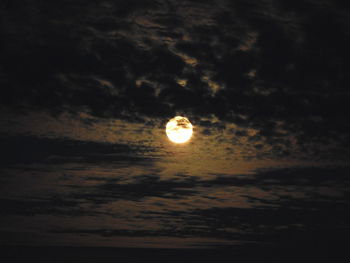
[{"xmin": 0, "ymin": 137, "xmax": 350, "ymax": 248}]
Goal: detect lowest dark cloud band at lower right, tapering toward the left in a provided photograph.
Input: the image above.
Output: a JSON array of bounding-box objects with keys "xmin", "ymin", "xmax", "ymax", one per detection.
[{"xmin": 53, "ymin": 195, "xmax": 349, "ymax": 249}]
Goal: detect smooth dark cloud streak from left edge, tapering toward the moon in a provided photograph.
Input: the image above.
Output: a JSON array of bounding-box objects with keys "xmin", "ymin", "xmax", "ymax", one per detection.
[{"xmin": 0, "ymin": 136, "xmax": 153, "ymax": 165}]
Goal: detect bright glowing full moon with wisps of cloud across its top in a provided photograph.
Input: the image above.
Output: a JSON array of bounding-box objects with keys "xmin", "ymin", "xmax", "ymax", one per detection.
[{"xmin": 165, "ymin": 116, "xmax": 193, "ymax": 143}]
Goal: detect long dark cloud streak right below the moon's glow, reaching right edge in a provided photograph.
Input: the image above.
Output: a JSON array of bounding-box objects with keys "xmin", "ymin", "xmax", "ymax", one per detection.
[{"xmin": 59, "ymin": 167, "xmax": 350, "ymax": 207}]
